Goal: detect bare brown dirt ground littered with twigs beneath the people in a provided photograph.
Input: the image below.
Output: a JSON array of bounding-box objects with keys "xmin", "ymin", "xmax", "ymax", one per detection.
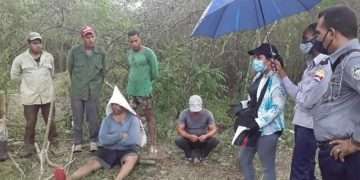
[{"xmin": 0, "ymin": 129, "xmax": 300, "ymax": 180}]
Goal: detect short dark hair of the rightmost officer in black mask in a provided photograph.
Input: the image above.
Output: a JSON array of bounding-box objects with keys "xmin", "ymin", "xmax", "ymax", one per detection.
[{"xmin": 319, "ymin": 6, "xmax": 358, "ymax": 39}]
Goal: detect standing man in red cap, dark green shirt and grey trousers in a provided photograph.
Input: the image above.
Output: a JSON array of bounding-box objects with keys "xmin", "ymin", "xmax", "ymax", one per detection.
[{"xmin": 68, "ymin": 26, "xmax": 105, "ymax": 152}]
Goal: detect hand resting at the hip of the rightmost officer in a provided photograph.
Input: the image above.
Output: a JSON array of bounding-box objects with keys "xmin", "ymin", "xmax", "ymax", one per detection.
[{"xmin": 330, "ymin": 139, "xmax": 359, "ymax": 162}]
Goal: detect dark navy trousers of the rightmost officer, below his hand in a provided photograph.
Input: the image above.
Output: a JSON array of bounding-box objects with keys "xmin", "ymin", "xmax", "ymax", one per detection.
[{"xmin": 319, "ymin": 143, "xmax": 360, "ymax": 180}]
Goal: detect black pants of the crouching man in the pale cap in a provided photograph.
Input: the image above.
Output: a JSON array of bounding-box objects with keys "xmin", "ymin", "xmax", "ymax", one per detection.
[{"xmin": 175, "ymin": 137, "xmax": 219, "ymax": 158}]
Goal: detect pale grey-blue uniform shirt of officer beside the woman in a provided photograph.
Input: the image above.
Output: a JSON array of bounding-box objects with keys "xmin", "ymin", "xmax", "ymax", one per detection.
[{"xmin": 282, "ymin": 54, "xmax": 331, "ymax": 129}]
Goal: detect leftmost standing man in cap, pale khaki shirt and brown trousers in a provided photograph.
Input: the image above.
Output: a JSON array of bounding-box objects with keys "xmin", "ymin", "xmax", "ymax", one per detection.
[{"xmin": 10, "ymin": 32, "xmax": 57, "ymax": 157}]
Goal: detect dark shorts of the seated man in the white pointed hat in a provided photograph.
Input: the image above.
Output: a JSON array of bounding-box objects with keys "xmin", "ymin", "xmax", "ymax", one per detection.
[{"xmin": 95, "ymin": 148, "xmax": 138, "ymax": 169}]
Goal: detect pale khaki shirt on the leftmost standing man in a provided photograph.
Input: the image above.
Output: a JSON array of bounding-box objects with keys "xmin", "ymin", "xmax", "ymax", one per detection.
[{"xmin": 10, "ymin": 50, "xmax": 55, "ymax": 105}]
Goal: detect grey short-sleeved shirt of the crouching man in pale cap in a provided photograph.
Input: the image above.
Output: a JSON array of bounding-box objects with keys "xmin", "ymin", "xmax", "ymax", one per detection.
[{"xmin": 179, "ymin": 109, "xmax": 215, "ymax": 135}]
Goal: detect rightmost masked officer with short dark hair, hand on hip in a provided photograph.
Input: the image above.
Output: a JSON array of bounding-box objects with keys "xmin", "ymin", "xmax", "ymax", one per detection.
[{"xmin": 313, "ymin": 6, "xmax": 360, "ymax": 180}]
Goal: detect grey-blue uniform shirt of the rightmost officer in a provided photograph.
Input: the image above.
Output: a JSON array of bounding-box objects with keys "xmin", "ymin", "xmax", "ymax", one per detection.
[{"xmin": 313, "ymin": 39, "xmax": 360, "ymax": 142}]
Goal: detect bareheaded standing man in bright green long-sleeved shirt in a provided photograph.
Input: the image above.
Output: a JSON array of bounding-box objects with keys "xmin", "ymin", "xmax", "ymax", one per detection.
[{"xmin": 127, "ymin": 31, "xmax": 159, "ymax": 155}]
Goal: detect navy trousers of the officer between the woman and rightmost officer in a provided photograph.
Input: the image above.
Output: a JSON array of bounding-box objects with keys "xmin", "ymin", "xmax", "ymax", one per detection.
[{"xmin": 290, "ymin": 125, "xmax": 317, "ymax": 180}]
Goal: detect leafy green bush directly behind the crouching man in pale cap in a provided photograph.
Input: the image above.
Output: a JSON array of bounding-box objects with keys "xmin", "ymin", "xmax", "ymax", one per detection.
[{"xmin": 154, "ymin": 43, "xmax": 227, "ymax": 136}]
